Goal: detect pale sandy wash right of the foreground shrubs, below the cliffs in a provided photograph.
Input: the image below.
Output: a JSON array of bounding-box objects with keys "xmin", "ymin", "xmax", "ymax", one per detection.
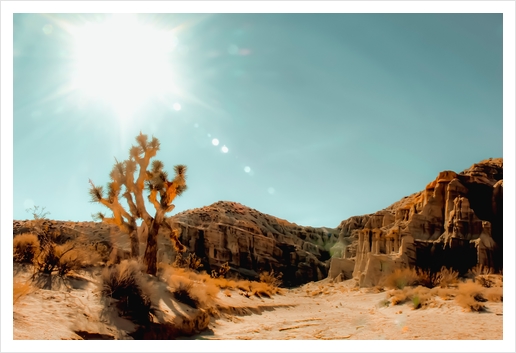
[{"xmin": 196, "ymin": 282, "xmax": 503, "ymax": 340}]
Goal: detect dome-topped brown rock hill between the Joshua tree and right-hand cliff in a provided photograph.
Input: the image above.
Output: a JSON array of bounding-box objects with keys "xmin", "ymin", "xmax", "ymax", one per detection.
[{"xmin": 169, "ymin": 201, "xmax": 338, "ymax": 286}]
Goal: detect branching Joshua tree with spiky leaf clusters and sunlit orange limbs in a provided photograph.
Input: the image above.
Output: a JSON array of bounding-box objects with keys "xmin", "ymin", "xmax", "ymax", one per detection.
[{"xmin": 90, "ymin": 132, "xmax": 186, "ymax": 275}]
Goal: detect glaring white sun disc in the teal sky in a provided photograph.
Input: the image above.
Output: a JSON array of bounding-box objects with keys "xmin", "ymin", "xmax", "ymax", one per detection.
[{"xmin": 71, "ymin": 14, "xmax": 177, "ymax": 117}]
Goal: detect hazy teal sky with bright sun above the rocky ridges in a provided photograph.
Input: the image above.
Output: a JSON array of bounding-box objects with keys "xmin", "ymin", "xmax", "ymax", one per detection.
[{"xmin": 13, "ymin": 13, "xmax": 503, "ymax": 227}]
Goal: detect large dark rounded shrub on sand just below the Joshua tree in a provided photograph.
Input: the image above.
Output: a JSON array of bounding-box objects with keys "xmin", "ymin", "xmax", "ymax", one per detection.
[{"xmin": 100, "ymin": 260, "xmax": 152, "ymax": 324}]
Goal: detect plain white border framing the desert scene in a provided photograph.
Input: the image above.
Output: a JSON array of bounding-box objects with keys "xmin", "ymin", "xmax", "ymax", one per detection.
[{"xmin": 0, "ymin": 1, "xmax": 516, "ymax": 352}]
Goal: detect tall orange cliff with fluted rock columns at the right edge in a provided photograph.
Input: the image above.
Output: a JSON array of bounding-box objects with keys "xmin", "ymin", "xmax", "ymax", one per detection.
[{"xmin": 330, "ymin": 158, "xmax": 503, "ymax": 285}]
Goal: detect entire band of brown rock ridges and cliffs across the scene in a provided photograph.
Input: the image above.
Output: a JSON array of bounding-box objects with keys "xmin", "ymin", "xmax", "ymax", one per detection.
[{"xmin": 13, "ymin": 158, "xmax": 503, "ymax": 286}]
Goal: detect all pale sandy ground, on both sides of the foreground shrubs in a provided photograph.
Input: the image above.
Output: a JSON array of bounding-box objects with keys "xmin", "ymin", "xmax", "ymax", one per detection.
[{"xmin": 13, "ymin": 266, "xmax": 503, "ymax": 340}]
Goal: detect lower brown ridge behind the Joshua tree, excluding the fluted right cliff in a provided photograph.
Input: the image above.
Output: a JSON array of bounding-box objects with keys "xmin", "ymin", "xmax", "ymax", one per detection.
[{"xmin": 13, "ymin": 201, "xmax": 338, "ymax": 286}]
